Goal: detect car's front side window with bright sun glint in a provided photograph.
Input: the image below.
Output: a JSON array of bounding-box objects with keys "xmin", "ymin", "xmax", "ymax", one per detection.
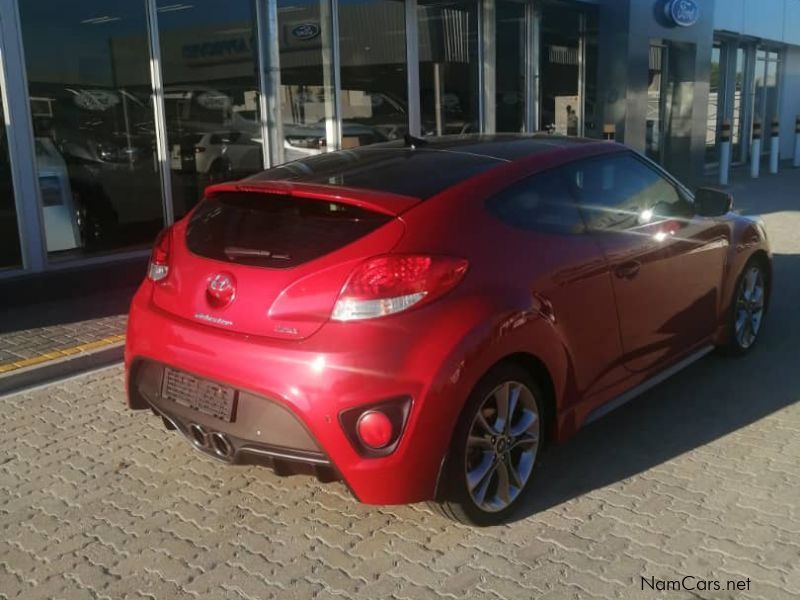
[{"xmin": 569, "ymin": 154, "xmax": 692, "ymax": 230}]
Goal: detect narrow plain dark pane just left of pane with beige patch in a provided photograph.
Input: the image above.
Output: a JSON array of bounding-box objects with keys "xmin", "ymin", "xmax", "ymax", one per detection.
[{"xmin": 495, "ymin": 0, "xmax": 525, "ymax": 131}]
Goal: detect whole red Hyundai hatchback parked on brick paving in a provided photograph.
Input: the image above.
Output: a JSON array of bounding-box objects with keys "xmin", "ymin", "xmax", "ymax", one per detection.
[{"xmin": 126, "ymin": 135, "xmax": 772, "ymax": 524}]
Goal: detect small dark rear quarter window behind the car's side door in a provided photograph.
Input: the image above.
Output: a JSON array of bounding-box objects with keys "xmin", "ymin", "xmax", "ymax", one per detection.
[{"xmin": 486, "ymin": 169, "xmax": 584, "ymax": 234}]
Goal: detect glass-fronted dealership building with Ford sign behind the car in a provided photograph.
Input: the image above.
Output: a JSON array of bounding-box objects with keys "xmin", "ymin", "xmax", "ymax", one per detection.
[{"xmin": 0, "ymin": 0, "xmax": 800, "ymax": 279}]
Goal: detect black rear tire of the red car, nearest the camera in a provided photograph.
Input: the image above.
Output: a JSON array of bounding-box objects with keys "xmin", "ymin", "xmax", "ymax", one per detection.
[{"xmin": 432, "ymin": 363, "xmax": 547, "ymax": 527}]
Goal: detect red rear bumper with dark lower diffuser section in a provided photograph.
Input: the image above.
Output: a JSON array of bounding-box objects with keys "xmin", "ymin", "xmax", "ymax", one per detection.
[{"xmin": 125, "ymin": 283, "xmax": 461, "ymax": 504}]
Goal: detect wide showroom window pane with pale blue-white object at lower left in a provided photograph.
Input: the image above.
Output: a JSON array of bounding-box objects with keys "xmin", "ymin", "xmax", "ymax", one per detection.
[{"xmin": 20, "ymin": 0, "xmax": 163, "ymax": 255}]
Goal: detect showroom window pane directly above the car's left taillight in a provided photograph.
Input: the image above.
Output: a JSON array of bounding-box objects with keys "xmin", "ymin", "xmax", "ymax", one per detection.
[{"xmin": 157, "ymin": 0, "xmax": 263, "ymax": 218}]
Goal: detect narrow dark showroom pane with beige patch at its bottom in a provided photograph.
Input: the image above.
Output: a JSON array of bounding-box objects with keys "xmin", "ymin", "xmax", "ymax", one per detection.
[{"xmin": 541, "ymin": 6, "xmax": 583, "ymax": 136}]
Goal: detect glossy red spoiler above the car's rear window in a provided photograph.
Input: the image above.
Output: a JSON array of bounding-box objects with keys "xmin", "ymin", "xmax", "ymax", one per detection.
[{"xmin": 206, "ymin": 180, "xmax": 422, "ymax": 217}]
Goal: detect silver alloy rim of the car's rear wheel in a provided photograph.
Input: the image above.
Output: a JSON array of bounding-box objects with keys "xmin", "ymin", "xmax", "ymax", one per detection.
[{"xmin": 464, "ymin": 381, "xmax": 541, "ymax": 513}]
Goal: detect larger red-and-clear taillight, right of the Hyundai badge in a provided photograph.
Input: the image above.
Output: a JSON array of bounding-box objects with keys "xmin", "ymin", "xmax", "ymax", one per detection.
[{"xmin": 331, "ymin": 254, "xmax": 468, "ymax": 321}]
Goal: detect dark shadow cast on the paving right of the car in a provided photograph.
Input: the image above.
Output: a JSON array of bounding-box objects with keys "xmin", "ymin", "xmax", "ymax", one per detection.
[{"xmin": 513, "ymin": 255, "xmax": 800, "ymax": 519}]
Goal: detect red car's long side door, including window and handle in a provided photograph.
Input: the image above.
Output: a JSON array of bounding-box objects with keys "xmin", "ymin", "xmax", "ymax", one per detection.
[{"xmin": 570, "ymin": 153, "xmax": 728, "ymax": 372}]
